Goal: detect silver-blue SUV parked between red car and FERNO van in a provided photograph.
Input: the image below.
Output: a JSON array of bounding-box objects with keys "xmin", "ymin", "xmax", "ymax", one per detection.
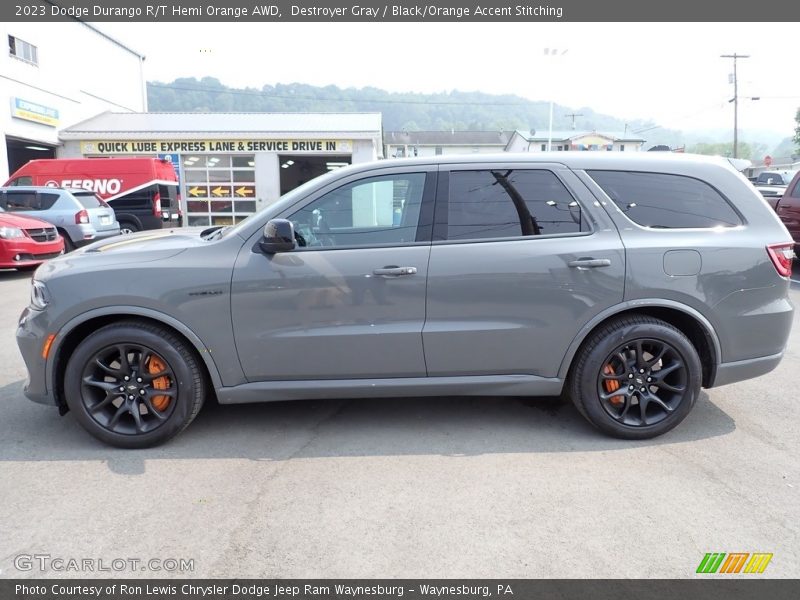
[{"xmin": 0, "ymin": 186, "xmax": 120, "ymax": 251}]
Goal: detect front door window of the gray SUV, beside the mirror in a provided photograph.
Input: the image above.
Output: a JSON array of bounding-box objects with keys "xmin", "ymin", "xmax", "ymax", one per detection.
[{"xmin": 289, "ymin": 173, "xmax": 425, "ymax": 247}]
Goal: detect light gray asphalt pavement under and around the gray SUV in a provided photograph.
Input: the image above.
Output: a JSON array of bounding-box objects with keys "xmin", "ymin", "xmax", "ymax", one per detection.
[{"xmin": 0, "ymin": 271, "xmax": 800, "ymax": 578}]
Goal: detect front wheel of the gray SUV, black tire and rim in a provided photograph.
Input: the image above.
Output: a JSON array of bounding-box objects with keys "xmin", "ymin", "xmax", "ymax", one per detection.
[{"xmin": 64, "ymin": 321, "xmax": 206, "ymax": 448}]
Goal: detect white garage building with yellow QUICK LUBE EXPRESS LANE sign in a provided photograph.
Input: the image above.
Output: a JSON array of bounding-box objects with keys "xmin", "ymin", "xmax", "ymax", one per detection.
[{"xmin": 58, "ymin": 112, "xmax": 383, "ymax": 226}]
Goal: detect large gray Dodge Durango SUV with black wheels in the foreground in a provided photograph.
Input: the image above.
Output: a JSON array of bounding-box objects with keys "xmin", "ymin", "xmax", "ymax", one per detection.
[{"xmin": 17, "ymin": 152, "xmax": 793, "ymax": 448}]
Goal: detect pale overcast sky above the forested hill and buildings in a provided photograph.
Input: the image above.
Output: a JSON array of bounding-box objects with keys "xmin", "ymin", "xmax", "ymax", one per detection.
[{"xmin": 97, "ymin": 23, "xmax": 800, "ymax": 136}]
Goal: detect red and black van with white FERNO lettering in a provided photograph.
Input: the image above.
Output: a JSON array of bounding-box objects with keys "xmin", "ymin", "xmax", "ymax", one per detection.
[{"xmin": 5, "ymin": 158, "xmax": 181, "ymax": 233}]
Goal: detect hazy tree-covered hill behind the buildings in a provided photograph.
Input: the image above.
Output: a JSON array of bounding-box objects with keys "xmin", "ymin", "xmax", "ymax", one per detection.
[{"xmin": 147, "ymin": 77, "xmax": 668, "ymax": 143}]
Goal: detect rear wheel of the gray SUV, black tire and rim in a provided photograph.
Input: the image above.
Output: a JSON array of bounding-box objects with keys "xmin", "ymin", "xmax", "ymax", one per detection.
[{"xmin": 568, "ymin": 316, "xmax": 702, "ymax": 440}]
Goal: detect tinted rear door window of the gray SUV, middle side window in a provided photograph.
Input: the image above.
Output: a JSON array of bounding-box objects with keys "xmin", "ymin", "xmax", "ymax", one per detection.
[{"xmin": 447, "ymin": 169, "xmax": 588, "ymax": 240}]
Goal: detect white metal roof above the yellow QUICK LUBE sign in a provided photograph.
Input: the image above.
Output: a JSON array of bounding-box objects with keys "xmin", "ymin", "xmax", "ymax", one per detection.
[{"xmin": 59, "ymin": 111, "xmax": 382, "ymax": 140}]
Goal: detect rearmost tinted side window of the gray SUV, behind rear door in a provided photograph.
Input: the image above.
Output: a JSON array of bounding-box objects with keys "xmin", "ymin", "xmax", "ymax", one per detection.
[{"xmin": 587, "ymin": 171, "xmax": 742, "ymax": 229}]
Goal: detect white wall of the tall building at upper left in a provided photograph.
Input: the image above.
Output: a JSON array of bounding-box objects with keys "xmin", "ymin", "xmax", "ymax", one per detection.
[{"xmin": 0, "ymin": 22, "xmax": 146, "ymax": 180}]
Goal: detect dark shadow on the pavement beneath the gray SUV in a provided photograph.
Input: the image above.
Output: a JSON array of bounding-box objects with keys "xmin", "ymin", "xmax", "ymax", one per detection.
[{"xmin": 0, "ymin": 381, "xmax": 736, "ymax": 475}]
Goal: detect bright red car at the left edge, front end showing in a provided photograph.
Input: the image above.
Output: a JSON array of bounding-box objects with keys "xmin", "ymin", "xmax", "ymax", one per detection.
[{"xmin": 0, "ymin": 208, "xmax": 64, "ymax": 271}]
